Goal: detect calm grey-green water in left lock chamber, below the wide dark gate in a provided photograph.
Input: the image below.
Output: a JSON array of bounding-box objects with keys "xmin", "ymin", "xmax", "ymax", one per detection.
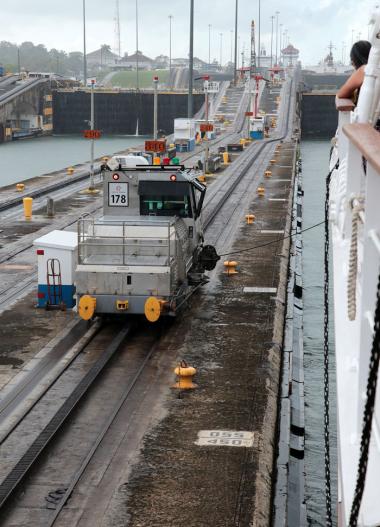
[{"xmin": 0, "ymin": 136, "xmax": 145, "ymax": 187}]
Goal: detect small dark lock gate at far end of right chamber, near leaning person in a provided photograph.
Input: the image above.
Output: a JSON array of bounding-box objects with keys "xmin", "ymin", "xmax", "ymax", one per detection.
[{"xmin": 301, "ymin": 93, "xmax": 338, "ymax": 139}]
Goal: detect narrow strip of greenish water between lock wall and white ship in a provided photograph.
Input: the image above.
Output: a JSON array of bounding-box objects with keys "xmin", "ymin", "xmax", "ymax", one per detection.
[{"xmin": 301, "ymin": 140, "xmax": 337, "ymax": 526}]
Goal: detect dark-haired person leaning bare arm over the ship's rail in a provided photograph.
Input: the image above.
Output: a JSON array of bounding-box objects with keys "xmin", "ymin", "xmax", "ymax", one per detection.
[{"xmin": 336, "ymin": 40, "xmax": 371, "ymax": 104}]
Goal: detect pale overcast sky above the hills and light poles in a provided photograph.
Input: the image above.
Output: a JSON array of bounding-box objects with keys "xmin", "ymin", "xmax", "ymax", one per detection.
[{"xmin": 0, "ymin": 0, "xmax": 375, "ymax": 64}]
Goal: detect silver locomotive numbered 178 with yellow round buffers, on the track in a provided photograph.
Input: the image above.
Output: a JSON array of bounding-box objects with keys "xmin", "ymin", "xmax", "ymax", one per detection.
[{"xmin": 76, "ymin": 156, "xmax": 217, "ymax": 321}]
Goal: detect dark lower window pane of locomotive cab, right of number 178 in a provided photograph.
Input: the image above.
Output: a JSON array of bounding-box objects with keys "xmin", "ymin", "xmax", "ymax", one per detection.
[{"xmin": 140, "ymin": 195, "xmax": 193, "ymax": 218}]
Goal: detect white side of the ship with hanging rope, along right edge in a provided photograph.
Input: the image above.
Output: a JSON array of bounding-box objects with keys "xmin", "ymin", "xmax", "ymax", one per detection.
[{"xmin": 330, "ymin": 36, "xmax": 380, "ymax": 526}]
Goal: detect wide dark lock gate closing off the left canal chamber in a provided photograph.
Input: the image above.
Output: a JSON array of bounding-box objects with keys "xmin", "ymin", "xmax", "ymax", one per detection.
[{"xmin": 53, "ymin": 91, "xmax": 204, "ymax": 135}]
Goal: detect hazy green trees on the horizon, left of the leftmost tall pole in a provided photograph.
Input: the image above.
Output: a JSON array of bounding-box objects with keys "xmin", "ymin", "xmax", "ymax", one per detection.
[{"xmin": 0, "ymin": 40, "xmax": 83, "ymax": 78}]
